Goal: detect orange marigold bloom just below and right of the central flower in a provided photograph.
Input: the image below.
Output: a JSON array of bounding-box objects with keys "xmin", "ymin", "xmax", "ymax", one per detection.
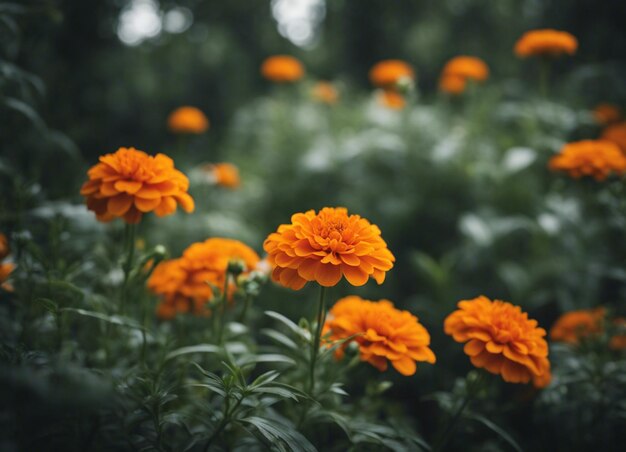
[{"xmin": 324, "ymin": 295, "xmax": 436, "ymax": 376}]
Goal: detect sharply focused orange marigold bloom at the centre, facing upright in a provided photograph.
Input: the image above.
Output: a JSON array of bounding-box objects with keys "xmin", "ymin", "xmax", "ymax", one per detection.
[{"xmin": 263, "ymin": 207, "xmax": 395, "ymax": 290}]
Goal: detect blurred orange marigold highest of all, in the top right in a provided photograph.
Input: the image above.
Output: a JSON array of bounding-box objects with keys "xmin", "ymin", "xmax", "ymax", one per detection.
[{"xmin": 515, "ymin": 29, "xmax": 578, "ymax": 58}]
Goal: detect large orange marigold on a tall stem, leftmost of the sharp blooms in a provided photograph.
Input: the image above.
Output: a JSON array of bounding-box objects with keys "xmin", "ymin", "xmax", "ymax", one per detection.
[{"xmin": 80, "ymin": 148, "xmax": 194, "ymax": 223}]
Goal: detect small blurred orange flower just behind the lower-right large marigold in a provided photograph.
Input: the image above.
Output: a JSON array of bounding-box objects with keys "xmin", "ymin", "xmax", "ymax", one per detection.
[{"xmin": 550, "ymin": 308, "xmax": 606, "ymax": 344}]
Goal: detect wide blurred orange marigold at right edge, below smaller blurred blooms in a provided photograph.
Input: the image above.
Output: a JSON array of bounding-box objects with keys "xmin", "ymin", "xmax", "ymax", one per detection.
[{"xmin": 548, "ymin": 140, "xmax": 626, "ymax": 181}]
